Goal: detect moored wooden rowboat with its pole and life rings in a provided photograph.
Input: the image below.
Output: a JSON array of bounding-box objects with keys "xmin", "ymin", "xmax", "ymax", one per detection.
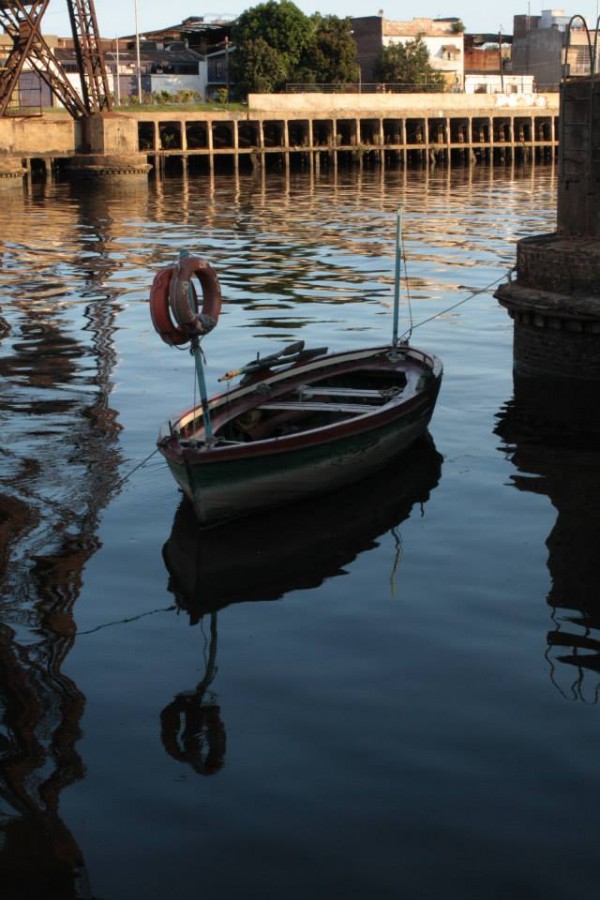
[{"xmin": 150, "ymin": 219, "xmax": 442, "ymax": 526}]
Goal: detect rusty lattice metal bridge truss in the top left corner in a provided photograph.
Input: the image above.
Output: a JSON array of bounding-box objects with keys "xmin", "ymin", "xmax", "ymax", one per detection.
[{"xmin": 0, "ymin": 0, "xmax": 111, "ymax": 119}]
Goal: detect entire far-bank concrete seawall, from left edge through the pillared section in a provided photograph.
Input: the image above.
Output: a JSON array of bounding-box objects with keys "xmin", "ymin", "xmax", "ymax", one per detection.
[{"xmin": 0, "ymin": 94, "xmax": 559, "ymax": 180}]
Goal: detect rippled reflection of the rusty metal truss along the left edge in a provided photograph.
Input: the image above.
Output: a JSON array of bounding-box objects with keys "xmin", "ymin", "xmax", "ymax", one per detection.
[{"xmin": 0, "ymin": 185, "xmax": 127, "ymax": 900}]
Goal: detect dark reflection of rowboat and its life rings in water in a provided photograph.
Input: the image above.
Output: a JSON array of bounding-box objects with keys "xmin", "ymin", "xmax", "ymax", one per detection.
[{"xmin": 161, "ymin": 436, "xmax": 442, "ymax": 775}]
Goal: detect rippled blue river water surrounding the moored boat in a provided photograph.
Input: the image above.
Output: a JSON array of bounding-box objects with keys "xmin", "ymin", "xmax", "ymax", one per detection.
[{"xmin": 0, "ymin": 167, "xmax": 600, "ymax": 900}]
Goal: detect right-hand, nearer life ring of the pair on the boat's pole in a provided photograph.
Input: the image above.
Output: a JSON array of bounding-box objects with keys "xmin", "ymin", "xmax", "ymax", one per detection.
[{"xmin": 169, "ymin": 256, "xmax": 223, "ymax": 334}]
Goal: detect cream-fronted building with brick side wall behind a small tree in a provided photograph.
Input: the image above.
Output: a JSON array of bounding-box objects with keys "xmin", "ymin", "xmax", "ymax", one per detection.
[{"xmin": 351, "ymin": 15, "xmax": 464, "ymax": 90}]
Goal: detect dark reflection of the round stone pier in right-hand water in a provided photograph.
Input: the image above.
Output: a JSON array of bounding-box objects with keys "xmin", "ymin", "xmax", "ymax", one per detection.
[{"xmin": 496, "ymin": 402, "xmax": 600, "ymax": 702}]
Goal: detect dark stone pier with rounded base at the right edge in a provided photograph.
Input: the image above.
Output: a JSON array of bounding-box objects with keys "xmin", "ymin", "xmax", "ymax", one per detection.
[{"xmin": 495, "ymin": 78, "xmax": 600, "ymax": 431}]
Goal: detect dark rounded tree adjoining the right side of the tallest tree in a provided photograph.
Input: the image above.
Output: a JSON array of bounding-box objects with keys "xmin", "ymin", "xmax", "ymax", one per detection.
[{"xmin": 294, "ymin": 13, "xmax": 358, "ymax": 84}]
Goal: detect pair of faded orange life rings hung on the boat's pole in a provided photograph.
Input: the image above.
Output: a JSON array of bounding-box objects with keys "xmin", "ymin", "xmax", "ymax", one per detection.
[{"xmin": 150, "ymin": 256, "xmax": 222, "ymax": 346}]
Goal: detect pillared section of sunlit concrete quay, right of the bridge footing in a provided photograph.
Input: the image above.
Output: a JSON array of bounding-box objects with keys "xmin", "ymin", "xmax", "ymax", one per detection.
[{"xmin": 138, "ymin": 94, "xmax": 558, "ymax": 173}]
